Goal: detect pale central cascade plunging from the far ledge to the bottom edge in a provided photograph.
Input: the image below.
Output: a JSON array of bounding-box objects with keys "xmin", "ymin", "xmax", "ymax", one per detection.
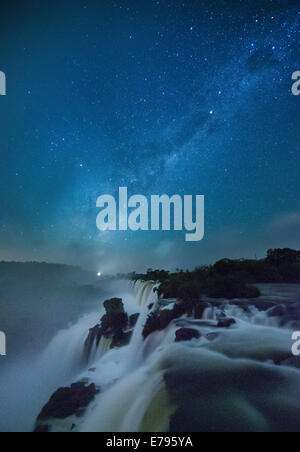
[{"xmin": 34, "ymin": 281, "xmax": 170, "ymax": 431}]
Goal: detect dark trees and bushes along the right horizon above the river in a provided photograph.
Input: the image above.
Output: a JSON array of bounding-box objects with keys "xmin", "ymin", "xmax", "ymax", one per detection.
[{"xmin": 134, "ymin": 248, "xmax": 300, "ymax": 301}]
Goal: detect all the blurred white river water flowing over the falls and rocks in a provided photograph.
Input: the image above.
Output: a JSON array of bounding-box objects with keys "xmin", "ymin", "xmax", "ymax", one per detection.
[{"xmin": 3, "ymin": 281, "xmax": 300, "ymax": 432}]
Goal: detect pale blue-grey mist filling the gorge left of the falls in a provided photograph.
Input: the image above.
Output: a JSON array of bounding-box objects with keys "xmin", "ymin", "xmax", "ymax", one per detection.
[{"xmin": 0, "ymin": 263, "xmax": 129, "ymax": 432}]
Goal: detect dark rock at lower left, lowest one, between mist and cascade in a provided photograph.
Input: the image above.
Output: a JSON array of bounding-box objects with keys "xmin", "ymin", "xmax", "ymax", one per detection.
[{"xmin": 37, "ymin": 382, "xmax": 99, "ymax": 422}]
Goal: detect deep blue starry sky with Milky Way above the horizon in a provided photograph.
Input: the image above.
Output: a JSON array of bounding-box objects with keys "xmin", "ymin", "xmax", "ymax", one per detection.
[{"xmin": 0, "ymin": 0, "xmax": 300, "ymax": 273}]
